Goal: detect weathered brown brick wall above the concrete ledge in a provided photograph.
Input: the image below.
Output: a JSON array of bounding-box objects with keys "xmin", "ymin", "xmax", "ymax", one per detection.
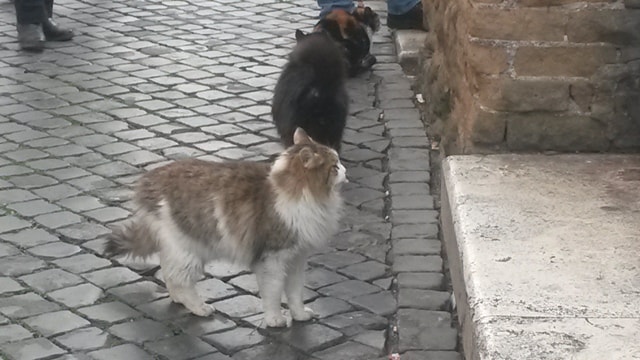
[{"xmin": 422, "ymin": 0, "xmax": 640, "ymax": 154}]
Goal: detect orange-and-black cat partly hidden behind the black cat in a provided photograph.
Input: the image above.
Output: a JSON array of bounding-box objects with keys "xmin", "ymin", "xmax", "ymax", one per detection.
[{"xmin": 313, "ymin": 6, "xmax": 380, "ymax": 76}]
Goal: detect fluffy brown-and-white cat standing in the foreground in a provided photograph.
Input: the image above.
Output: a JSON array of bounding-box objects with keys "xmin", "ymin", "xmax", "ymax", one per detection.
[{"xmin": 105, "ymin": 129, "xmax": 347, "ymax": 327}]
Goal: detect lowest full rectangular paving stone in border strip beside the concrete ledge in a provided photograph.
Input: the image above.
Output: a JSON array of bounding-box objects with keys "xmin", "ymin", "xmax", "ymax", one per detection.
[{"xmin": 398, "ymin": 309, "xmax": 458, "ymax": 352}]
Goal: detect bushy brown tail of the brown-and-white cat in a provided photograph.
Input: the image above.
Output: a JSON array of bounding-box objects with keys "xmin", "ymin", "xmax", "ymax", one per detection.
[{"xmin": 104, "ymin": 219, "xmax": 158, "ymax": 258}]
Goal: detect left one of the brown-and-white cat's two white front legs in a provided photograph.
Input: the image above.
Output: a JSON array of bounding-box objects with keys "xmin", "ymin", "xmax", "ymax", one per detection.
[{"xmin": 253, "ymin": 253, "xmax": 287, "ymax": 327}]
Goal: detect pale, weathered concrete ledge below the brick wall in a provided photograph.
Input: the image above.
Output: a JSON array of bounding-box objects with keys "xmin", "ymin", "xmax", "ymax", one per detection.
[{"xmin": 442, "ymin": 155, "xmax": 640, "ymax": 360}]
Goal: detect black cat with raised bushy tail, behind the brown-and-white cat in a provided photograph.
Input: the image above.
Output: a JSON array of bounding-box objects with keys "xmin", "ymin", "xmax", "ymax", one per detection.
[{"xmin": 271, "ymin": 30, "xmax": 349, "ymax": 151}]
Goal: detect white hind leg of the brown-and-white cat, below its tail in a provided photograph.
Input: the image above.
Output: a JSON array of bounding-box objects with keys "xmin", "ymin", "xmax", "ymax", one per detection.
[{"xmin": 158, "ymin": 224, "xmax": 215, "ymax": 316}]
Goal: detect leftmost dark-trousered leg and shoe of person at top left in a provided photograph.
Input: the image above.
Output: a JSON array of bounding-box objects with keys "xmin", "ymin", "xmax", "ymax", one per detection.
[{"xmin": 14, "ymin": 0, "xmax": 47, "ymax": 51}]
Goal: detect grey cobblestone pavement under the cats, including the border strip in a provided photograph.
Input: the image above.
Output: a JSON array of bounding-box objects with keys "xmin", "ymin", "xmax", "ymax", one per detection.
[{"xmin": 0, "ymin": 0, "xmax": 460, "ymax": 360}]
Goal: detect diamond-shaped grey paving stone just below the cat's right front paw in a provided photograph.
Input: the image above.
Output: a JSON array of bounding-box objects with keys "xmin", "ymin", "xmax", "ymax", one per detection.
[{"xmin": 278, "ymin": 323, "xmax": 343, "ymax": 353}]
